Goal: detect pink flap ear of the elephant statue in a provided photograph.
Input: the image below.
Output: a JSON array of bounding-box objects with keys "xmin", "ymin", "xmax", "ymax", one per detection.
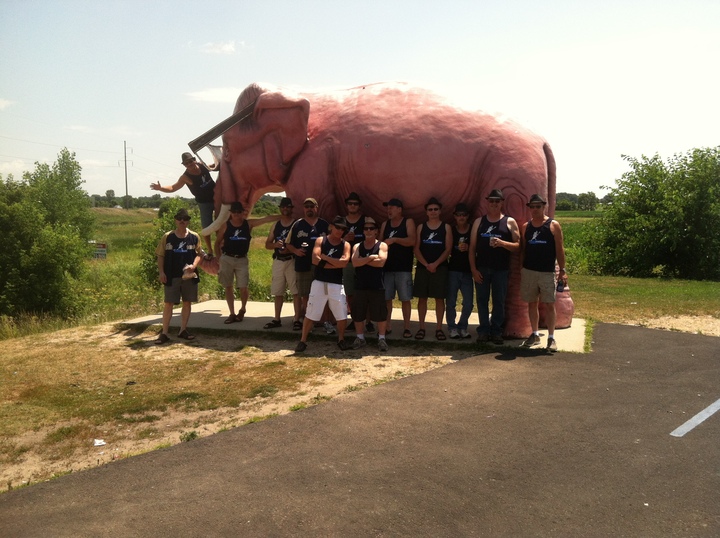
[{"xmin": 253, "ymin": 92, "xmax": 310, "ymax": 183}]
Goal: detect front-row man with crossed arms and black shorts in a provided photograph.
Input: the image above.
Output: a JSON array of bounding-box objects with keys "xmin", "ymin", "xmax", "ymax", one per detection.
[{"xmin": 351, "ymin": 217, "xmax": 388, "ymax": 351}]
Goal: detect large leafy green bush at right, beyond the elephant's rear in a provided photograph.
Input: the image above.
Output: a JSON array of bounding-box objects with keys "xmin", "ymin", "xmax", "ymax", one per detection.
[{"xmin": 586, "ymin": 146, "xmax": 720, "ymax": 280}]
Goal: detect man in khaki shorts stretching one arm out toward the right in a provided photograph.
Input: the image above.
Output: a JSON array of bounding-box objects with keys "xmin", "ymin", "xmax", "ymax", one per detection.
[{"xmin": 215, "ymin": 202, "xmax": 275, "ymax": 323}]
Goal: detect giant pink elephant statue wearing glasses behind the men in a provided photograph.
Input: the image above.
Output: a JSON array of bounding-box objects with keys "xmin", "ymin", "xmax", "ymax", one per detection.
[{"xmin": 190, "ymin": 83, "xmax": 572, "ymax": 338}]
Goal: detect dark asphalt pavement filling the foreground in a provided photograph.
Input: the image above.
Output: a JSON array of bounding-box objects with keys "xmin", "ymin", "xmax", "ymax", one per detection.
[{"xmin": 0, "ymin": 324, "xmax": 720, "ymax": 537}]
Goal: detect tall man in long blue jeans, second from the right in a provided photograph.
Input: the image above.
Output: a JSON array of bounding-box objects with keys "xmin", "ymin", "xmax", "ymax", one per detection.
[{"xmin": 470, "ymin": 189, "xmax": 520, "ymax": 345}]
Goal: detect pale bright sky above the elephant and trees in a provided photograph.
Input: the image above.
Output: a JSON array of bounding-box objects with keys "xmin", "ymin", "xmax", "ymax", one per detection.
[{"xmin": 0, "ymin": 0, "xmax": 720, "ymax": 197}]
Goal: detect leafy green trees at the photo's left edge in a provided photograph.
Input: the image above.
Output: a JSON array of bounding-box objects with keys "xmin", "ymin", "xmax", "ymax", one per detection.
[{"xmin": 0, "ymin": 149, "xmax": 94, "ymax": 317}]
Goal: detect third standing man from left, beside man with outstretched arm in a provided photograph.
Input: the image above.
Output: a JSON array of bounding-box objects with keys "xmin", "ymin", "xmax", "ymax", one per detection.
[{"xmin": 264, "ymin": 198, "xmax": 302, "ymax": 331}]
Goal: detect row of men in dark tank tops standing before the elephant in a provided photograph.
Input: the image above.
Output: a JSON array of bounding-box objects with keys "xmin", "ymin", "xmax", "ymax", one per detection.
[{"xmin": 153, "ymin": 154, "xmax": 567, "ymax": 352}]
